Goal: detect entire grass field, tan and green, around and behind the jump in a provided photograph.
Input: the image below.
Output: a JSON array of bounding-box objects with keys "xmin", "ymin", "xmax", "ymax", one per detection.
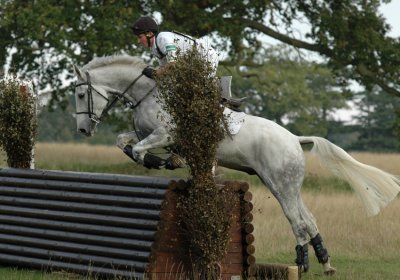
[{"xmin": 0, "ymin": 143, "xmax": 400, "ymax": 280}]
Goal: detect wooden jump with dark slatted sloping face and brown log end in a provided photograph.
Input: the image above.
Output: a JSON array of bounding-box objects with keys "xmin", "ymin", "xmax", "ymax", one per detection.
[{"xmin": 0, "ymin": 168, "xmax": 300, "ymax": 280}]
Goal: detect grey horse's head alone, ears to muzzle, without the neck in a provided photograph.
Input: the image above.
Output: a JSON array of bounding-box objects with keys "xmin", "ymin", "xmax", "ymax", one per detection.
[{"xmin": 74, "ymin": 66, "xmax": 109, "ymax": 136}]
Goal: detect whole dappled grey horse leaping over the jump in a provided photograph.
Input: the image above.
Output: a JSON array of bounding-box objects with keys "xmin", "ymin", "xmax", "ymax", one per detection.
[{"xmin": 75, "ymin": 56, "xmax": 400, "ymax": 275}]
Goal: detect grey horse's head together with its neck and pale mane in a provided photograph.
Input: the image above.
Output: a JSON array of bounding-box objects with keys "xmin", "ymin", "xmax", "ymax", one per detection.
[{"xmin": 74, "ymin": 55, "xmax": 155, "ymax": 136}]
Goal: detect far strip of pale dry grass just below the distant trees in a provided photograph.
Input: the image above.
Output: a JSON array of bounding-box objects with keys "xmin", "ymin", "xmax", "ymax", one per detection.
[{"xmin": 0, "ymin": 143, "xmax": 400, "ymax": 178}]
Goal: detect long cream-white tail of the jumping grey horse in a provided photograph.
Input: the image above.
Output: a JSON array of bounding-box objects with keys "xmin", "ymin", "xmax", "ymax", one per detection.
[{"xmin": 299, "ymin": 136, "xmax": 400, "ymax": 215}]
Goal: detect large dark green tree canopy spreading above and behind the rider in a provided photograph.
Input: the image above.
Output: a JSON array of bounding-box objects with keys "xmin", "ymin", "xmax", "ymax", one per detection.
[{"xmin": 0, "ymin": 0, "xmax": 400, "ymax": 101}]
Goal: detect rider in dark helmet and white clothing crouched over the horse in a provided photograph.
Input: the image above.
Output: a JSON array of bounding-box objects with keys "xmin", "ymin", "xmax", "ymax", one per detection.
[{"xmin": 132, "ymin": 16, "xmax": 218, "ymax": 79}]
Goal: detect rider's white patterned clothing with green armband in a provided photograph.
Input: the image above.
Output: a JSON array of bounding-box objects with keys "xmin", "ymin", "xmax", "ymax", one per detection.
[{"xmin": 151, "ymin": 32, "xmax": 218, "ymax": 72}]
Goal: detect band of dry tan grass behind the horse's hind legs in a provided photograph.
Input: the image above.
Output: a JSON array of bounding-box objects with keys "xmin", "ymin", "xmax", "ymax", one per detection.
[{"xmin": 252, "ymin": 188, "xmax": 400, "ymax": 264}]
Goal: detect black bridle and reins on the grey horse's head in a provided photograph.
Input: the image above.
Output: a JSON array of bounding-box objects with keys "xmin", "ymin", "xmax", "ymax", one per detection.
[{"xmin": 75, "ymin": 71, "xmax": 155, "ymax": 124}]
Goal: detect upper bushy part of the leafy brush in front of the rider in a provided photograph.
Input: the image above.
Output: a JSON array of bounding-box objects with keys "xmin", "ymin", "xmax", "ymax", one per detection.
[{"xmin": 157, "ymin": 47, "xmax": 224, "ymax": 179}]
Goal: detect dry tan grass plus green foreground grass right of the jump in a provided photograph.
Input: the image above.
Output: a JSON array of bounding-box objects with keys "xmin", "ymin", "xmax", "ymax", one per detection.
[{"xmin": 252, "ymin": 188, "xmax": 400, "ymax": 280}]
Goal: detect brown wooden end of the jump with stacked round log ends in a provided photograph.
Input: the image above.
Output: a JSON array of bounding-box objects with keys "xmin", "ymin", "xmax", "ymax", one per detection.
[{"xmin": 147, "ymin": 181, "xmax": 255, "ymax": 280}]
